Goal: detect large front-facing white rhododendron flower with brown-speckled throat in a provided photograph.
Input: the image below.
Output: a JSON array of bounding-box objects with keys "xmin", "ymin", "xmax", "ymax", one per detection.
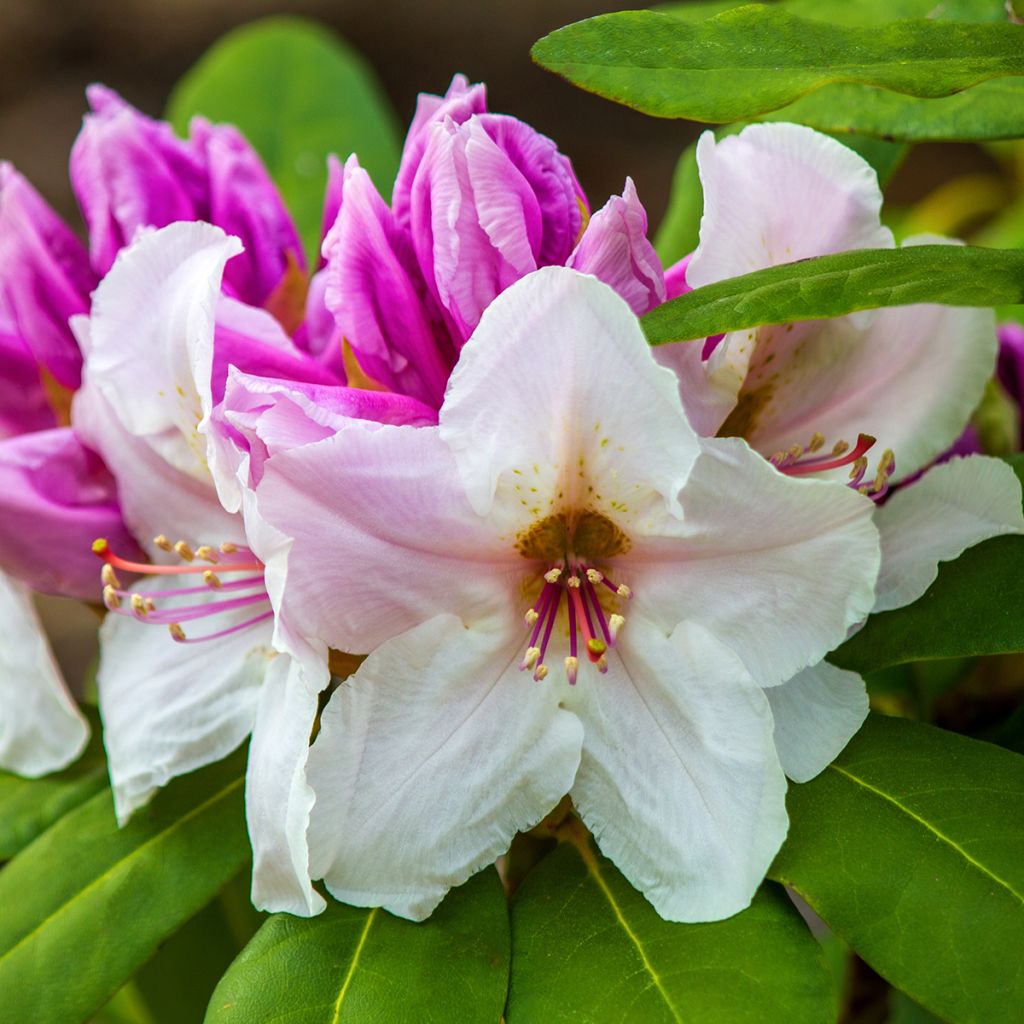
[{"xmin": 237, "ymin": 267, "xmax": 879, "ymax": 921}]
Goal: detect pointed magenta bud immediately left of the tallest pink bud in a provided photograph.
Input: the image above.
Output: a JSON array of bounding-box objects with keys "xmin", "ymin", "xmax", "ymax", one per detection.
[{"xmin": 324, "ymin": 157, "xmax": 455, "ymax": 408}]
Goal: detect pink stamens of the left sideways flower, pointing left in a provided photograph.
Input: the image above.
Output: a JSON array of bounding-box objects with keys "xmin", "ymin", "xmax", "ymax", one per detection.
[{"xmin": 92, "ymin": 535, "xmax": 273, "ymax": 643}]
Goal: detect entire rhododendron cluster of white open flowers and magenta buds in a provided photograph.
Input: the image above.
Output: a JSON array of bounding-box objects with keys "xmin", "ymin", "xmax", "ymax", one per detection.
[{"xmin": 0, "ymin": 77, "xmax": 1024, "ymax": 921}]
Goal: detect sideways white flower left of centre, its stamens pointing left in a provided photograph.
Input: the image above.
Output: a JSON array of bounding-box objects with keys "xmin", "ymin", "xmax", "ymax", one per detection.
[{"xmin": 73, "ymin": 223, "xmax": 436, "ymax": 912}]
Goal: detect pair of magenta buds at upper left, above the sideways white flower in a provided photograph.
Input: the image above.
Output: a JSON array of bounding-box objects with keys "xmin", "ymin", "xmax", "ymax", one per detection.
[{"xmin": 71, "ymin": 85, "xmax": 305, "ymax": 305}]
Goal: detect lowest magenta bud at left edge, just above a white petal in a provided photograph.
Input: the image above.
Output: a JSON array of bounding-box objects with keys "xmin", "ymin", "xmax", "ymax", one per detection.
[{"xmin": 0, "ymin": 428, "xmax": 138, "ymax": 601}]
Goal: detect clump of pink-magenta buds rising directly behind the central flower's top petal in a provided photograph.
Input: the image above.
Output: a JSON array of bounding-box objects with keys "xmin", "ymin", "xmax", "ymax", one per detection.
[{"xmin": 324, "ymin": 76, "xmax": 666, "ymax": 408}]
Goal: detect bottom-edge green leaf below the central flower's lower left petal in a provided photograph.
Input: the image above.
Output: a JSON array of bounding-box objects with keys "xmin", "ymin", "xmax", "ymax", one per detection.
[{"xmin": 206, "ymin": 871, "xmax": 509, "ymax": 1024}]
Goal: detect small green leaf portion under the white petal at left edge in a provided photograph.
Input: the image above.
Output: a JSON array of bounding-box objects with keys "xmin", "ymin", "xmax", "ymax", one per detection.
[{"xmin": 0, "ymin": 709, "xmax": 106, "ymax": 860}]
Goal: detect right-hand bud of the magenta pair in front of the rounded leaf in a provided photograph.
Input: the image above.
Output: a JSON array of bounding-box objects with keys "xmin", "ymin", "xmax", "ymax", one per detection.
[{"xmin": 190, "ymin": 118, "xmax": 306, "ymax": 306}]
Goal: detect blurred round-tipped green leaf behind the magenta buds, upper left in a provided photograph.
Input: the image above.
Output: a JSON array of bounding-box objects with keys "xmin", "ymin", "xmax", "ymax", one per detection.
[{"xmin": 168, "ymin": 17, "xmax": 399, "ymax": 265}]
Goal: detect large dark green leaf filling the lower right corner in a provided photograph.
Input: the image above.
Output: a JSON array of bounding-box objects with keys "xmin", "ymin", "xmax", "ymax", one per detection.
[{"xmin": 769, "ymin": 715, "xmax": 1024, "ymax": 1024}]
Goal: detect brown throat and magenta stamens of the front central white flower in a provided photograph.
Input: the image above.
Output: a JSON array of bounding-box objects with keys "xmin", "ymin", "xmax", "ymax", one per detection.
[{"xmin": 516, "ymin": 509, "xmax": 632, "ymax": 686}]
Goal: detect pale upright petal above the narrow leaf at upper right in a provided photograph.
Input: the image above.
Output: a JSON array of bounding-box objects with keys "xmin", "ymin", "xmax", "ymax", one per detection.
[{"xmin": 686, "ymin": 123, "xmax": 893, "ymax": 288}]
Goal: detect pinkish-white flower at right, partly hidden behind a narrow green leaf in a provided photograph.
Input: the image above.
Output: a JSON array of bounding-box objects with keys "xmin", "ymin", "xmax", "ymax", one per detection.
[{"xmin": 654, "ymin": 124, "xmax": 1024, "ymax": 781}]
